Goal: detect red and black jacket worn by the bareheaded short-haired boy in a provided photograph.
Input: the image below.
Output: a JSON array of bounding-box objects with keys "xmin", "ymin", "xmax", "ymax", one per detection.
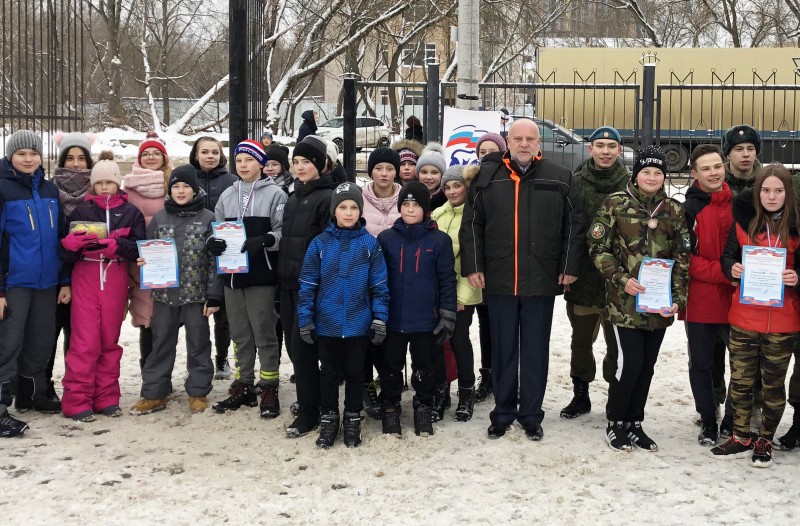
[{"xmin": 678, "ymin": 183, "xmax": 734, "ymax": 323}]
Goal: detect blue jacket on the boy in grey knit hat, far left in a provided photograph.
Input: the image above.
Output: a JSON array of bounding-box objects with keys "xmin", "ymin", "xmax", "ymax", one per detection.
[{"xmin": 0, "ymin": 157, "xmax": 69, "ymax": 296}]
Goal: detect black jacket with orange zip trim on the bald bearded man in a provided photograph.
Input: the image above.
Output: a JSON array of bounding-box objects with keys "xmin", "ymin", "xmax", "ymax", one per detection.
[{"xmin": 459, "ymin": 152, "xmax": 586, "ymax": 296}]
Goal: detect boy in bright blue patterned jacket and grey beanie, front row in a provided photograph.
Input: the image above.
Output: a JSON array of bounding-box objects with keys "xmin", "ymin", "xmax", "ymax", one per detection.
[{"xmin": 297, "ymin": 183, "xmax": 389, "ymax": 449}]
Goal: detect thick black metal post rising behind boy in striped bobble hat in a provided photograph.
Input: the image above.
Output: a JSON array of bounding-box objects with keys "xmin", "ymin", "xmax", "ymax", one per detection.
[{"xmin": 228, "ymin": 0, "xmax": 248, "ymax": 173}]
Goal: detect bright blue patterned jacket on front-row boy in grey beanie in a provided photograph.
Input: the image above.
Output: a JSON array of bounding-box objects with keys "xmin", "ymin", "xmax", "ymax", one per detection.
[{"xmin": 297, "ymin": 219, "xmax": 389, "ymax": 338}]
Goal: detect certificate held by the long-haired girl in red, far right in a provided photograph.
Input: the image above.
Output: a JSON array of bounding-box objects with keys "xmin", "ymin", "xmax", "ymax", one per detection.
[{"xmin": 739, "ymin": 245, "xmax": 786, "ymax": 307}]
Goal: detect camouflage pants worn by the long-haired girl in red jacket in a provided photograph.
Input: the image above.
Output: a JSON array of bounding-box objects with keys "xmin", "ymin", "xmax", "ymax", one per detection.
[{"xmin": 730, "ymin": 325, "xmax": 797, "ymax": 440}]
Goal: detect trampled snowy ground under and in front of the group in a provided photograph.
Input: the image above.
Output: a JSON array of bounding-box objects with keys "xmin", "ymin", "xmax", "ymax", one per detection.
[{"xmin": 0, "ymin": 299, "xmax": 800, "ymax": 525}]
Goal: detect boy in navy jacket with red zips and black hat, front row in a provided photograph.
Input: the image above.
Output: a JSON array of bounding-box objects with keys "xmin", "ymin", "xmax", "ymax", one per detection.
[{"xmin": 378, "ymin": 181, "xmax": 456, "ymax": 436}]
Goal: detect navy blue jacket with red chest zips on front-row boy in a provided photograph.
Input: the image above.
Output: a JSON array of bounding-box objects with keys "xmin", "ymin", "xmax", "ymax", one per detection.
[{"xmin": 378, "ymin": 218, "xmax": 456, "ymax": 332}]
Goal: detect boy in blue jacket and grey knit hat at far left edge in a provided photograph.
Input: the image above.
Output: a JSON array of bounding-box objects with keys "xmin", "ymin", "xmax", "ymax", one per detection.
[{"xmin": 0, "ymin": 130, "xmax": 71, "ymax": 437}]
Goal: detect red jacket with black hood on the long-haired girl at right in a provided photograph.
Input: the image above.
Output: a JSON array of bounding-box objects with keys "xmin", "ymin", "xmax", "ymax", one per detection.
[{"xmin": 722, "ymin": 190, "xmax": 800, "ymax": 334}]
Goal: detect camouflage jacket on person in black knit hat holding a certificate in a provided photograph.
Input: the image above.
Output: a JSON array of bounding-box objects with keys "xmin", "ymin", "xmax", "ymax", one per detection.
[{"xmin": 587, "ymin": 185, "xmax": 690, "ymax": 330}]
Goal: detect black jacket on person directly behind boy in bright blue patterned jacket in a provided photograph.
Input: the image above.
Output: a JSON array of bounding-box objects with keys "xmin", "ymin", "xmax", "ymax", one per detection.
[{"xmin": 278, "ymin": 175, "xmax": 338, "ymax": 290}]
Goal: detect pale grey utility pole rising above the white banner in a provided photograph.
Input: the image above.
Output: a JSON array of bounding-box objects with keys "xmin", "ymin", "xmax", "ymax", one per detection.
[{"xmin": 456, "ymin": 0, "xmax": 481, "ymax": 110}]
